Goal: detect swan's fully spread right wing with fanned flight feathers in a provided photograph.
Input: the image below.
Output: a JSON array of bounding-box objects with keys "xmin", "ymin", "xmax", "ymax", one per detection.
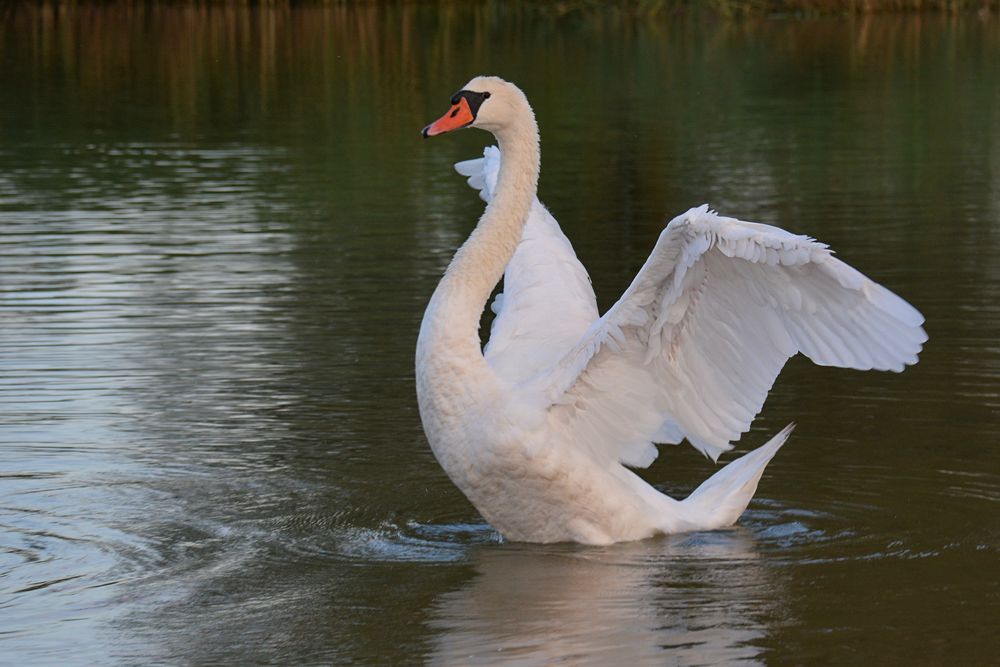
[{"xmin": 534, "ymin": 206, "xmax": 927, "ymax": 466}]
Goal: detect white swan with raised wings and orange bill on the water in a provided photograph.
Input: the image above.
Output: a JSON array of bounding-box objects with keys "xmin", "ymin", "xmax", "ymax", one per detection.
[{"xmin": 416, "ymin": 77, "xmax": 927, "ymax": 544}]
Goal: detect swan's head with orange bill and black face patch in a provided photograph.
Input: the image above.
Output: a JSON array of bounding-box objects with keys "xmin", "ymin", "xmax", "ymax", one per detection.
[{"xmin": 422, "ymin": 76, "xmax": 533, "ymax": 138}]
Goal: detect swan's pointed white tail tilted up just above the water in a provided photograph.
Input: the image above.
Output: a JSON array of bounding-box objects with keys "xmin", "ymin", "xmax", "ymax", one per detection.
[{"xmin": 681, "ymin": 424, "xmax": 795, "ymax": 530}]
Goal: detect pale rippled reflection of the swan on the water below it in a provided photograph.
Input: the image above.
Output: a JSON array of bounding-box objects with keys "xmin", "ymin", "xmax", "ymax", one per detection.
[{"xmin": 430, "ymin": 530, "xmax": 773, "ymax": 665}]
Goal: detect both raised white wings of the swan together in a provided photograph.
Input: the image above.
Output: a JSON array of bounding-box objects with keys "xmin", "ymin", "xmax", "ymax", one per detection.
[{"xmin": 455, "ymin": 147, "xmax": 927, "ymax": 467}]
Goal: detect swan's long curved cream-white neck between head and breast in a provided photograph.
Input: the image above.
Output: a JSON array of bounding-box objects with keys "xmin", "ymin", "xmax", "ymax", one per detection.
[{"xmin": 417, "ymin": 110, "xmax": 541, "ymax": 394}]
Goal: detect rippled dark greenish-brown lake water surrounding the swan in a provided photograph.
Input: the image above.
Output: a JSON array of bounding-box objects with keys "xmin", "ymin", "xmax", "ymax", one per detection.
[{"xmin": 0, "ymin": 5, "xmax": 1000, "ymax": 665}]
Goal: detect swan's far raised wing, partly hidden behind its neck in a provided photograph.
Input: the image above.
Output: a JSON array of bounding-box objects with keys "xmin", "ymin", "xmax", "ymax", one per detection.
[{"xmin": 455, "ymin": 146, "xmax": 599, "ymax": 383}]
